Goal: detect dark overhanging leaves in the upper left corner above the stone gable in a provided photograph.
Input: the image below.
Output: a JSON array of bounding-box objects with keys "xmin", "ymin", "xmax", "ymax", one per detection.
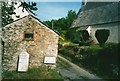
[{"xmin": 1, "ymin": 1, "xmax": 37, "ymax": 27}]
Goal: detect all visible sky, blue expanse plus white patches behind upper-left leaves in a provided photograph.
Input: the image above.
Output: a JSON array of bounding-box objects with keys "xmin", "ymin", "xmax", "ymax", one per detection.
[{"xmin": 13, "ymin": 0, "xmax": 81, "ymax": 21}]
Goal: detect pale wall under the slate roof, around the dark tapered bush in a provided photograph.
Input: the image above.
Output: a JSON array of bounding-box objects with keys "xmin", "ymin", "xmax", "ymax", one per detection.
[{"xmin": 90, "ymin": 23, "xmax": 120, "ymax": 43}]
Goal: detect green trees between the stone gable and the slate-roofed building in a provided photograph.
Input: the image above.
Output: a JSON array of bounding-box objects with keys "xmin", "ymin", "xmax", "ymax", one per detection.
[{"xmin": 43, "ymin": 10, "xmax": 77, "ymax": 41}]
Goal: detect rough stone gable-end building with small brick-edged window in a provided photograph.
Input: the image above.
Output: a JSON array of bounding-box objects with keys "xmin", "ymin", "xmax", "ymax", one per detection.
[{"xmin": 2, "ymin": 15, "xmax": 58, "ymax": 70}]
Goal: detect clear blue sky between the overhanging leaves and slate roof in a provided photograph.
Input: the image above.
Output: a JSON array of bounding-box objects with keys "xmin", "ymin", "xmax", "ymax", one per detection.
[{"xmin": 35, "ymin": 2, "xmax": 81, "ymax": 21}]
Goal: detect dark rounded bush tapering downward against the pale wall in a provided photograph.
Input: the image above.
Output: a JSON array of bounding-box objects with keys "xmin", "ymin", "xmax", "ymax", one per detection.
[{"xmin": 95, "ymin": 29, "xmax": 110, "ymax": 46}]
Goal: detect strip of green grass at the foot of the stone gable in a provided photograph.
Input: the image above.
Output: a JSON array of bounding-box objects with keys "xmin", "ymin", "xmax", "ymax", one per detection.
[{"xmin": 3, "ymin": 66, "xmax": 61, "ymax": 79}]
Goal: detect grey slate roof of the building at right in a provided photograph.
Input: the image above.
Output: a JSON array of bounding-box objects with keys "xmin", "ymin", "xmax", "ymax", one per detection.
[{"xmin": 71, "ymin": 2, "xmax": 120, "ymax": 28}]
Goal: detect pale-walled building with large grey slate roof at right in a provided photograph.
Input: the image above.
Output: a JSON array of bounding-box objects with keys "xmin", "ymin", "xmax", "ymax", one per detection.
[{"xmin": 71, "ymin": 0, "xmax": 120, "ymax": 43}]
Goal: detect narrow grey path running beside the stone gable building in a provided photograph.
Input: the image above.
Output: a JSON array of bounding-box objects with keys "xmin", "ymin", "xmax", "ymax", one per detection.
[{"xmin": 57, "ymin": 55, "xmax": 103, "ymax": 81}]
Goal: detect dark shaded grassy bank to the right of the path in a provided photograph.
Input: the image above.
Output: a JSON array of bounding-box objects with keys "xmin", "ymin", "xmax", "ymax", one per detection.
[{"xmin": 59, "ymin": 44, "xmax": 120, "ymax": 79}]
